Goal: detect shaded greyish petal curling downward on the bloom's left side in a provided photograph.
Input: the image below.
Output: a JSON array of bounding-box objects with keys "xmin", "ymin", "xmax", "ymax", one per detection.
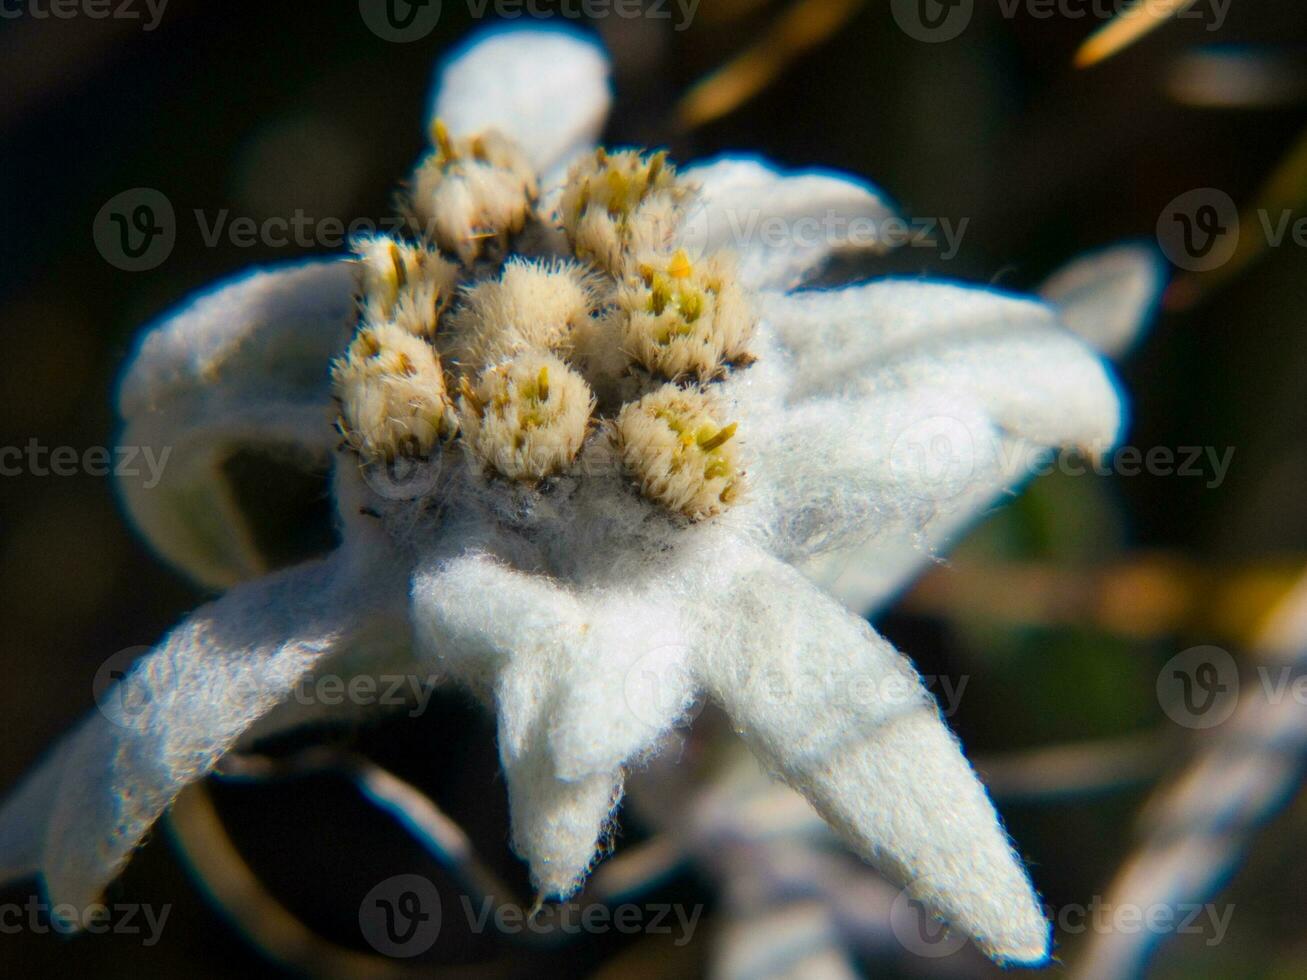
[{"xmin": 118, "ymin": 260, "xmax": 354, "ymax": 587}]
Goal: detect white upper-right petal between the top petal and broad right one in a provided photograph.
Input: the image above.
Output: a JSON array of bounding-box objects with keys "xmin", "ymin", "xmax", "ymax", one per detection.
[{"xmin": 681, "ymin": 157, "xmax": 894, "ymax": 289}]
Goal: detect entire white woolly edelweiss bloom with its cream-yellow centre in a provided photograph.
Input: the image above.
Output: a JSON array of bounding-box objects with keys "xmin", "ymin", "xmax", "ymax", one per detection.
[{"xmin": 0, "ymin": 30, "xmax": 1155, "ymax": 963}]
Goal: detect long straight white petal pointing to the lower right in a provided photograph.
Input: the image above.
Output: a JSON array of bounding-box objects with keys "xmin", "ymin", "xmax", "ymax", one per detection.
[{"xmin": 697, "ymin": 557, "xmax": 1050, "ymax": 963}]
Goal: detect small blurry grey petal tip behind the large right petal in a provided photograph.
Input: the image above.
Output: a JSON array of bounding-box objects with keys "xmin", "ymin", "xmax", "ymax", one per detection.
[{"xmin": 1039, "ymin": 244, "xmax": 1166, "ymax": 357}]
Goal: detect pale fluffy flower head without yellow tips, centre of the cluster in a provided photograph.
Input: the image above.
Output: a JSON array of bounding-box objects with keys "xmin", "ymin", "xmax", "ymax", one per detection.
[{"xmin": 444, "ymin": 259, "xmax": 597, "ymax": 374}]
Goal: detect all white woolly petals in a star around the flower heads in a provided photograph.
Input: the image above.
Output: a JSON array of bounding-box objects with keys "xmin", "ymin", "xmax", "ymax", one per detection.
[{"xmin": 0, "ymin": 29, "xmax": 1157, "ymax": 963}]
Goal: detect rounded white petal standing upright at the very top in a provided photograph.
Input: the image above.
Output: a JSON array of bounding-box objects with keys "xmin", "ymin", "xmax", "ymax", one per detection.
[{"xmin": 431, "ymin": 27, "xmax": 612, "ymax": 180}]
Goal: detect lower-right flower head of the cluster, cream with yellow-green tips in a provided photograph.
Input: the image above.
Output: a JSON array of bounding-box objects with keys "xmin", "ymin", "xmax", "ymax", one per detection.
[{"xmin": 616, "ymin": 384, "xmax": 744, "ymax": 520}]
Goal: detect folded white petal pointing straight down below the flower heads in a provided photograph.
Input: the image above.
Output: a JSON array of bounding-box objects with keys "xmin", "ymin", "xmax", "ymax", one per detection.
[{"xmin": 412, "ymin": 554, "xmax": 691, "ymax": 895}]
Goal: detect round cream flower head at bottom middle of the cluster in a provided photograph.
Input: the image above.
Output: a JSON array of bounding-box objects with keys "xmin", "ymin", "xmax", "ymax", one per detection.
[{"xmin": 459, "ymin": 351, "xmax": 595, "ymax": 483}]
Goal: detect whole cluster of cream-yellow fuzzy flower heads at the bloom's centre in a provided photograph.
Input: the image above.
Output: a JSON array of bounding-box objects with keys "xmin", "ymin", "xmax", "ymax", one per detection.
[{"xmin": 332, "ymin": 120, "xmax": 755, "ymax": 520}]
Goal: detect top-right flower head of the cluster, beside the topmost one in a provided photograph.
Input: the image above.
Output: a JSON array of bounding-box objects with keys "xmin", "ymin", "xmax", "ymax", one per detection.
[{"xmin": 559, "ymin": 148, "xmax": 689, "ymax": 274}]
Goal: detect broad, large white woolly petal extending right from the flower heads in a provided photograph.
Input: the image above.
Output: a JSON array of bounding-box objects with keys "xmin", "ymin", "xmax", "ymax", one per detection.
[{"xmin": 752, "ymin": 280, "xmax": 1124, "ymax": 613}]
